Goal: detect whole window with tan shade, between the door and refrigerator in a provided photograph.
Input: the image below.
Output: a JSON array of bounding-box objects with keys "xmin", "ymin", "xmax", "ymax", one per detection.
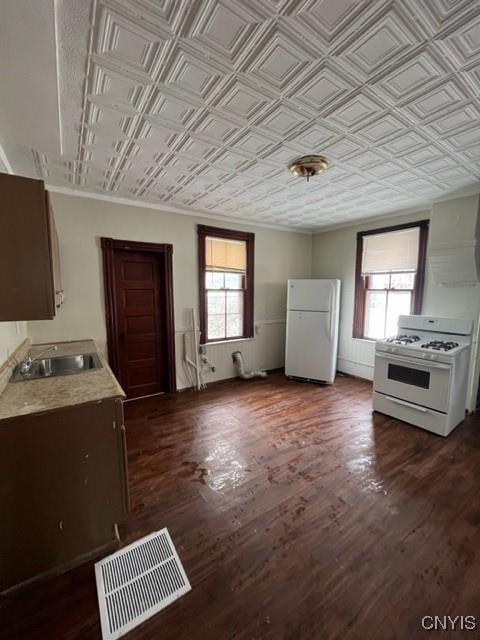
[{"xmin": 198, "ymin": 225, "xmax": 255, "ymax": 342}]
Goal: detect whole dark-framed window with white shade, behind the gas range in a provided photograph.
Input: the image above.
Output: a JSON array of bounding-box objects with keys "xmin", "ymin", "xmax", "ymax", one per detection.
[{"xmin": 353, "ymin": 220, "xmax": 428, "ymax": 339}]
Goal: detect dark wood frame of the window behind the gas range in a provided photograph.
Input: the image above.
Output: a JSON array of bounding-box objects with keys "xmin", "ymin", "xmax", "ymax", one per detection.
[{"xmin": 353, "ymin": 220, "xmax": 429, "ymax": 340}]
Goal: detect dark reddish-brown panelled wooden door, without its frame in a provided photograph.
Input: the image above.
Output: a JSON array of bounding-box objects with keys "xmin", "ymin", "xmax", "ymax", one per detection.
[{"xmin": 114, "ymin": 251, "xmax": 168, "ymax": 398}]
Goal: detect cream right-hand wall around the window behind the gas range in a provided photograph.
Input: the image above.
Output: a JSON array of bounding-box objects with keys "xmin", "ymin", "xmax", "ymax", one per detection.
[{"xmin": 312, "ymin": 198, "xmax": 480, "ymax": 408}]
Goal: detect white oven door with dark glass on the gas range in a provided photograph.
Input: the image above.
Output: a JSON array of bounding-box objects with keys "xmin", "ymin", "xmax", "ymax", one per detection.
[{"xmin": 374, "ymin": 351, "xmax": 452, "ymax": 413}]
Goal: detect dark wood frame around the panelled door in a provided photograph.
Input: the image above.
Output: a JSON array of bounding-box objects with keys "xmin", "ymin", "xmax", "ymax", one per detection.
[{"xmin": 100, "ymin": 238, "xmax": 177, "ymax": 393}]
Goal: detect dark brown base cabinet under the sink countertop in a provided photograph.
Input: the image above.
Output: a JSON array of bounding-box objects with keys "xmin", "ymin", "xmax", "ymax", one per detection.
[{"xmin": 0, "ymin": 398, "xmax": 128, "ymax": 592}]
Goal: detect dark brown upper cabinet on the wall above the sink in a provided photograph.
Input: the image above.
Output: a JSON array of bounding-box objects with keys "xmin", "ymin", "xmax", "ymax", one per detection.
[{"xmin": 0, "ymin": 173, "xmax": 63, "ymax": 322}]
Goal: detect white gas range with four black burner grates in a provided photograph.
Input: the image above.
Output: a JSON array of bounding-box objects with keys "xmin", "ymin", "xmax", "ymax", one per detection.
[{"xmin": 373, "ymin": 315, "xmax": 472, "ymax": 436}]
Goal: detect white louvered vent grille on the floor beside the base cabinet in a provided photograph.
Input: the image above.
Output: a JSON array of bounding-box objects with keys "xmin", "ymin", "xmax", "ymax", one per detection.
[{"xmin": 95, "ymin": 529, "xmax": 191, "ymax": 640}]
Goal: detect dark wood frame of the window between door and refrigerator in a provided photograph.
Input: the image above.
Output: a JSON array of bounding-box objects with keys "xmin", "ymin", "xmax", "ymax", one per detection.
[{"xmin": 197, "ymin": 224, "xmax": 255, "ymax": 344}]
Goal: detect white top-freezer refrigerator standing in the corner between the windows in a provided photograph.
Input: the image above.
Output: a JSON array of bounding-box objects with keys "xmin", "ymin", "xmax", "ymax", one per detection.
[{"xmin": 285, "ymin": 279, "xmax": 340, "ymax": 384}]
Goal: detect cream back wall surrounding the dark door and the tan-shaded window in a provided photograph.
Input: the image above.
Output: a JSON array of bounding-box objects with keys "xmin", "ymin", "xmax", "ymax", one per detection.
[{"xmin": 28, "ymin": 193, "xmax": 312, "ymax": 388}]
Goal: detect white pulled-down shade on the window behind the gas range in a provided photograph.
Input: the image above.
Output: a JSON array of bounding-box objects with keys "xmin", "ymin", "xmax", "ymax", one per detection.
[{"xmin": 362, "ymin": 227, "xmax": 420, "ymax": 275}]
